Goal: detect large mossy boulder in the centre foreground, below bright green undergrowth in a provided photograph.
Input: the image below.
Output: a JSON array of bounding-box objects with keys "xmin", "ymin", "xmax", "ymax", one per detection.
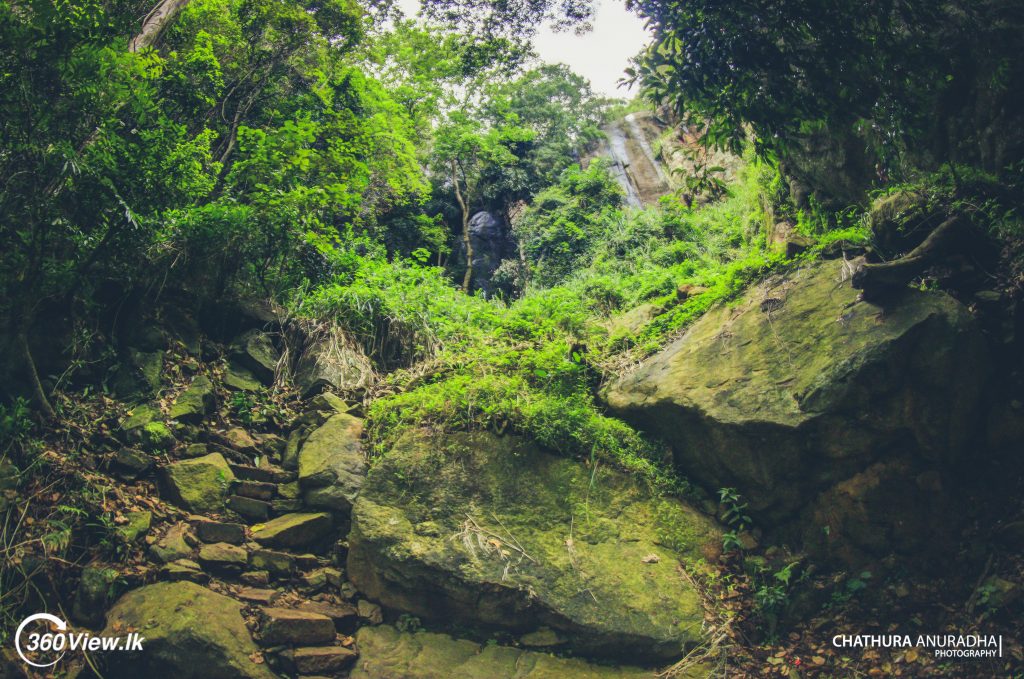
[{"xmin": 348, "ymin": 432, "xmax": 721, "ymax": 663}]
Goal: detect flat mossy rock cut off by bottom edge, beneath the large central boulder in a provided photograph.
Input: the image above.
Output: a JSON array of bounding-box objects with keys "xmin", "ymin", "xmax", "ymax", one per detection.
[{"xmin": 349, "ymin": 625, "xmax": 708, "ymax": 679}]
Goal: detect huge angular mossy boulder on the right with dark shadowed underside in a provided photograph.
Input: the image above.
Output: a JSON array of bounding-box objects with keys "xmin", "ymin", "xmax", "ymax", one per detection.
[{"xmin": 604, "ymin": 261, "xmax": 988, "ymax": 520}]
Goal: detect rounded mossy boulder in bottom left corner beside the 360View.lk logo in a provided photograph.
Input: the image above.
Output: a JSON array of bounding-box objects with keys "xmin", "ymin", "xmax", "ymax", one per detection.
[{"xmin": 103, "ymin": 582, "xmax": 274, "ymax": 679}]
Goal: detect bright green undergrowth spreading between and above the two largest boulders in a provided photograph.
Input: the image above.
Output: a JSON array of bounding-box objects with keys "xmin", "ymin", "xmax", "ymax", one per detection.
[{"xmin": 297, "ymin": 148, "xmax": 839, "ymax": 490}]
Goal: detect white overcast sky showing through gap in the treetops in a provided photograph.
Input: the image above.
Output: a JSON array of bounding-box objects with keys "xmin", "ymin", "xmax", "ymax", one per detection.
[{"xmin": 398, "ymin": 0, "xmax": 648, "ymax": 97}]
